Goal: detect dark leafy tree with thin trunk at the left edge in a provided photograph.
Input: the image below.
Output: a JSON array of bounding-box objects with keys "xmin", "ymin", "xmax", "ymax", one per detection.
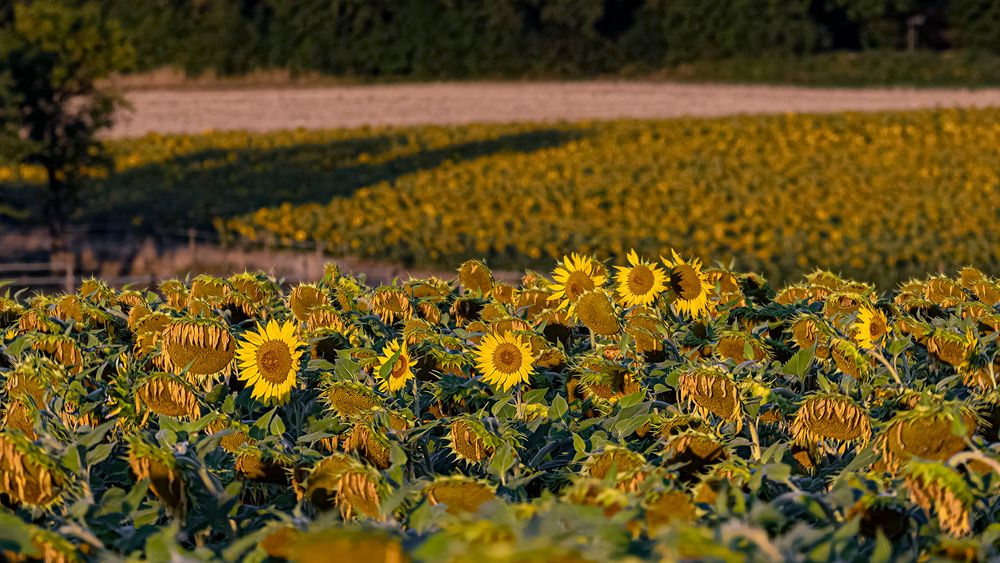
[{"xmin": 0, "ymin": 0, "xmax": 133, "ymax": 253}]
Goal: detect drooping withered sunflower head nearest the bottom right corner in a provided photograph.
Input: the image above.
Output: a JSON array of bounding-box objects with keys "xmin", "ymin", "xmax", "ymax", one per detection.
[{"xmin": 904, "ymin": 459, "xmax": 975, "ymax": 537}]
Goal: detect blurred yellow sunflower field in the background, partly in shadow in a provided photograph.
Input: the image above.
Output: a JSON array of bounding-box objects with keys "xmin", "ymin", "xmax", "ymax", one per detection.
[{"xmin": 0, "ymin": 109, "xmax": 1000, "ymax": 289}]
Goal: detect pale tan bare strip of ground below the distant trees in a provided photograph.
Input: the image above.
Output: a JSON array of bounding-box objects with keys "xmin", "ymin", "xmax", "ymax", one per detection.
[{"xmin": 111, "ymin": 82, "xmax": 1000, "ymax": 137}]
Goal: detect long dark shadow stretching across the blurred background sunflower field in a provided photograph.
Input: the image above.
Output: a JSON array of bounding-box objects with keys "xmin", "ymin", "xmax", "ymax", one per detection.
[{"xmin": 29, "ymin": 129, "xmax": 583, "ymax": 228}]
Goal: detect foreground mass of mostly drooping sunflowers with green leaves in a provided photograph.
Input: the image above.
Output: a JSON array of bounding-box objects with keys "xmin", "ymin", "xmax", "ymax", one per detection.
[{"xmin": 0, "ymin": 251, "xmax": 1000, "ymax": 562}]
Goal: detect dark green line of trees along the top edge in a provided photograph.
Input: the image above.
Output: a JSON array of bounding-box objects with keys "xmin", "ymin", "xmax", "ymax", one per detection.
[{"xmin": 82, "ymin": 0, "xmax": 1000, "ymax": 77}]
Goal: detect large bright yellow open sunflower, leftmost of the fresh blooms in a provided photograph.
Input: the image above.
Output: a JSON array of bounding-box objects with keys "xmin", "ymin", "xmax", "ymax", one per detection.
[{"xmin": 236, "ymin": 319, "xmax": 305, "ymax": 402}]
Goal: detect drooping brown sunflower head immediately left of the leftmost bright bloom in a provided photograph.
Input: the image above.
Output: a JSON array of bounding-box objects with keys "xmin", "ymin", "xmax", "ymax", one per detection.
[{"xmin": 162, "ymin": 317, "xmax": 236, "ymax": 377}]
